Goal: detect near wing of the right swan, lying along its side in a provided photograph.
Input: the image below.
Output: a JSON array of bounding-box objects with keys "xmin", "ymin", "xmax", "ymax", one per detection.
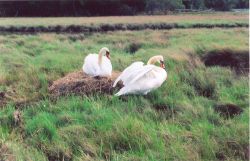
[{"xmin": 129, "ymin": 65, "xmax": 155, "ymax": 84}]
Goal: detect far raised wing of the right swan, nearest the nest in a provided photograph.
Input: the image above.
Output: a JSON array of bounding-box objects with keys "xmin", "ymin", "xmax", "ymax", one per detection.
[{"xmin": 113, "ymin": 62, "xmax": 144, "ymax": 87}]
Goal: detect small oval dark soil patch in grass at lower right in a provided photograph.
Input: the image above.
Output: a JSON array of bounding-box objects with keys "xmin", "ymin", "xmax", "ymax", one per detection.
[{"xmin": 214, "ymin": 104, "xmax": 243, "ymax": 118}]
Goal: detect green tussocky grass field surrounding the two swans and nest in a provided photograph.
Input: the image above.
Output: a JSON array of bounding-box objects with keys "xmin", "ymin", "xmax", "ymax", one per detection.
[{"xmin": 0, "ymin": 13, "xmax": 249, "ymax": 161}]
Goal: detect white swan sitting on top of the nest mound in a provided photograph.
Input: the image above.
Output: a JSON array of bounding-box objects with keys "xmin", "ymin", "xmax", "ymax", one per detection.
[{"xmin": 82, "ymin": 47, "xmax": 112, "ymax": 77}]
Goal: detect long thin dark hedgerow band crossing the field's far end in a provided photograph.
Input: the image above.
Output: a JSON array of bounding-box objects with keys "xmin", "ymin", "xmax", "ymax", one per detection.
[{"xmin": 0, "ymin": 23, "xmax": 249, "ymax": 33}]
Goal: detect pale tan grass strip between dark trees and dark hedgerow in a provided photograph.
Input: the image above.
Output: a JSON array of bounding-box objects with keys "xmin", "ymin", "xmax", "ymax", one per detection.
[{"xmin": 0, "ymin": 12, "xmax": 248, "ymax": 26}]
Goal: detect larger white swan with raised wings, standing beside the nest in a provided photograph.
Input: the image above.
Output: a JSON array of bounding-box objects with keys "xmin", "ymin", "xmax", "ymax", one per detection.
[{"xmin": 113, "ymin": 55, "xmax": 167, "ymax": 96}]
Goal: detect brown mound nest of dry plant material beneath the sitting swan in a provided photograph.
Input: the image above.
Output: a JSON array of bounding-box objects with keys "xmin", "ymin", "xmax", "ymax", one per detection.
[{"xmin": 49, "ymin": 71, "xmax": 121, "ymax": 98}]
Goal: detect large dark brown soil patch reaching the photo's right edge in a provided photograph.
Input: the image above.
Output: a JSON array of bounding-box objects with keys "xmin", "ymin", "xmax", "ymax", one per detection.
[{"xmin": 202, "ymin": 49, "xmax": 249, "ymax": 73}]
